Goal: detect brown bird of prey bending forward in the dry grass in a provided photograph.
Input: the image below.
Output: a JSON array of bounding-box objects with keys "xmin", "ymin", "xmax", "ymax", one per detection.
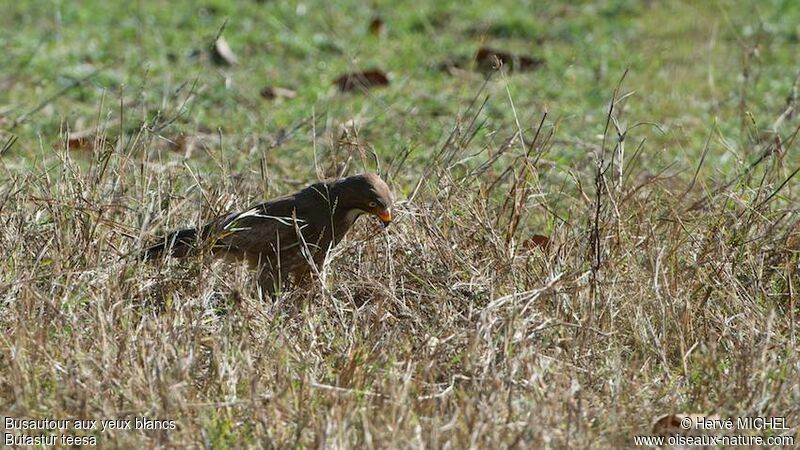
[{"xmin": 142, "ymin": 173, "xmax": 394, "ymax": 299}]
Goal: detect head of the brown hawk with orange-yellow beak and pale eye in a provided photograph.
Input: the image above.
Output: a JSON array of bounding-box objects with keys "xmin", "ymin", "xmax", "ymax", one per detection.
[{"xmin": 333, "ymin": 173, "xmax": 394, "ymax": 226}]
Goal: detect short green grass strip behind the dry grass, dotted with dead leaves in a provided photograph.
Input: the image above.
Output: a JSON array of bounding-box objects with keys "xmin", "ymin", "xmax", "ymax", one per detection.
[{"xmin": 0, "ymin": 1, "xmax": 800, "ymax": 170}]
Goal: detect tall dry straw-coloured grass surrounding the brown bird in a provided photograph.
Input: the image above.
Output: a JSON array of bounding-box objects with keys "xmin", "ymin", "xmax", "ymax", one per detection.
[{"xmin": 0, "ymin": 75, "xmax": 800, "ymax": 448}]
